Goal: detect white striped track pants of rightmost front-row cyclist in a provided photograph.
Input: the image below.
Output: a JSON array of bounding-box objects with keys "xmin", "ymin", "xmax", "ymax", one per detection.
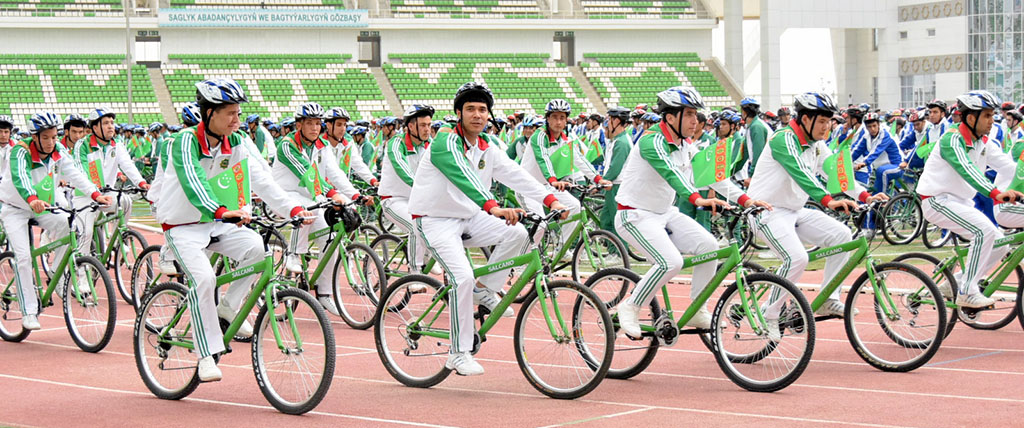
[{"xmin": 922, "ymin": 195, "xmax": 1010, "ymax": 294}]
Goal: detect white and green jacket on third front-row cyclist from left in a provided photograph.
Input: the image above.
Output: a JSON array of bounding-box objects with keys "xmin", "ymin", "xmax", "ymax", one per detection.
[{"xmin": 615, "ymin": 122, "xmax": 746, "ymax": 214}]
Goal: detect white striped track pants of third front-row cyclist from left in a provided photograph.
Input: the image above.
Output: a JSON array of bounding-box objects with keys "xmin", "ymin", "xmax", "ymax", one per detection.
[{"xmin": 615, "ymin": 207, "xmax": 718, "ymax": 306}]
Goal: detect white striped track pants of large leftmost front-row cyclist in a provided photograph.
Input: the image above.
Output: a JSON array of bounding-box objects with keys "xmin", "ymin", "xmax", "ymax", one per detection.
[{"xmin": 164, "ymin": 222, "xmax": 266, "ymax": 358}]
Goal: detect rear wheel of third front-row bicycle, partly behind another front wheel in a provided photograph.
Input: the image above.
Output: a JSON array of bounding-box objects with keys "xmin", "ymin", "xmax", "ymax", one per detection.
[{"xmin": 585, "ymin": 268, "xmax": 660, "ymax": 379}]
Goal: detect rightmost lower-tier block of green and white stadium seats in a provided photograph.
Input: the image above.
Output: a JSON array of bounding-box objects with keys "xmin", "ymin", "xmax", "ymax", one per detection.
[{"xmin": 580, "ymin": 52, "xmax": 734, "ymax": 110}]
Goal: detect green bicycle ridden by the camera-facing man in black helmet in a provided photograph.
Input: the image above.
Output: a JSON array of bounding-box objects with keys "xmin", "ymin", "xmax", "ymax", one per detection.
[{"xmin": 374, "ymin": 211, "xmax": 614, "ymax": 398}]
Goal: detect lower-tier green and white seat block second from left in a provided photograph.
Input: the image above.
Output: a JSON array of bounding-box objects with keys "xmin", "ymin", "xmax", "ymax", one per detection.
[{"xmin": 162, "ymin": 54, "xmax": 390, "ymax": 121}]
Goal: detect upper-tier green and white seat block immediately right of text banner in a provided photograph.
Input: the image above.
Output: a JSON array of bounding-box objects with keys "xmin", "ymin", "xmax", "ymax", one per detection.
[{"xmin": 387, "ymin": 0, "xmax": 544, "ymax": 19}]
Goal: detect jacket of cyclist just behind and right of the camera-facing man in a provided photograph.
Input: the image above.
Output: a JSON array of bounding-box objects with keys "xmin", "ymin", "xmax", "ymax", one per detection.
[{"xmin": 520, "ymin": 125, "xmax": 601, "ymax": 183}]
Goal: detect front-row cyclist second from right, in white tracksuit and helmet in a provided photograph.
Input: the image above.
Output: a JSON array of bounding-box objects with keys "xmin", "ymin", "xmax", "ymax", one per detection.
[{"xmin": 748, "ymin": 92, "xmax": 888, "ymax": 319}]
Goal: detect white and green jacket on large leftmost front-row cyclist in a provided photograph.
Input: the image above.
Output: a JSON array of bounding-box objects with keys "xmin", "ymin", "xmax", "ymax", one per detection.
[{"xmin": 150, "ymin": 124, "xmax": 302, "ymax": 230}]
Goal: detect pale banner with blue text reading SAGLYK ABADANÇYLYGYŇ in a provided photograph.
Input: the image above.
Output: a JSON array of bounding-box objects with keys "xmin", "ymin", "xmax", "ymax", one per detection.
[{"xmin": 160, "ymin": 8, "xmax": 370, "ymax": 27}]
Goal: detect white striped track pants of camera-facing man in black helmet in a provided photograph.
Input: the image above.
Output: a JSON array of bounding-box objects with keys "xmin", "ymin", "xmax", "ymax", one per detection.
[{"xmin": 416, "ymin": 211, "xmax": 529, "ymax": 353}]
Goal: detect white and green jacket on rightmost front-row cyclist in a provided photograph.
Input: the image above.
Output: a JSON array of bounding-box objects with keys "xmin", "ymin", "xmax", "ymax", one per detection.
[{"xmin": 918, "ymin": 120, "xmax": 1012, "ymax": 200}]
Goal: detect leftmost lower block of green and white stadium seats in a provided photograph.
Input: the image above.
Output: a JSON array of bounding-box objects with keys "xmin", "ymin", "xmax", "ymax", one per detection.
[{"xmin": 0, "ymin": 54, "xmax": 163, "ymax": 124}]
